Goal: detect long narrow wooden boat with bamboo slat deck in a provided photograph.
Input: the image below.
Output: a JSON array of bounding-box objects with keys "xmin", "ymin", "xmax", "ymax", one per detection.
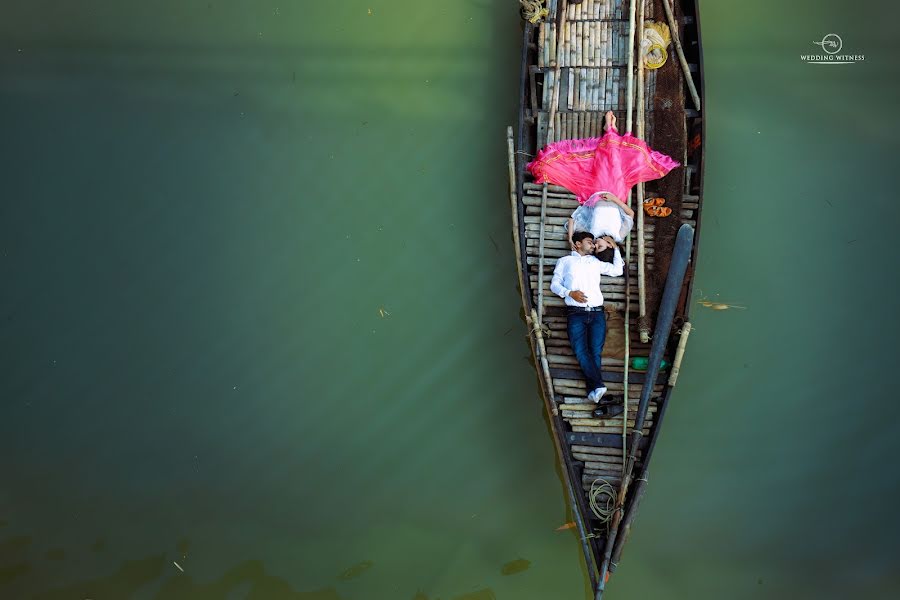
[{"xmin": 508, "ymin": 0, "xmax": 704, "ymax": 598}]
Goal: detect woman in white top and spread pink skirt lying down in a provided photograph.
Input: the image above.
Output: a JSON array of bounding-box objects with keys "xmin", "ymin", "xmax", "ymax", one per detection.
[{"xmin": 528, "ymin": 111, "xmax": 679, "ymax": 251}]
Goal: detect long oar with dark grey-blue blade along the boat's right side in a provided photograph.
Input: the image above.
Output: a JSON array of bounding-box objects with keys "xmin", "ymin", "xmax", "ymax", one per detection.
[{"xmin": 595, "ymin": 223, "xmax": 694, "ymax": 600}]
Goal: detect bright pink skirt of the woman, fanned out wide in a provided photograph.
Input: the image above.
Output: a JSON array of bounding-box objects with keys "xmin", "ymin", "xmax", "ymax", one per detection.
[{"xmin": 528, "ymin": 127, "xmax": 679, "ymax": 204}]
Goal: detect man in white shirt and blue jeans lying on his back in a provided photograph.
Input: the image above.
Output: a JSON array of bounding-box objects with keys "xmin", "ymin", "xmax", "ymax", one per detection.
[{"xmin": 550, "ymin": 231, "xmax": 625, "ymax": 402}]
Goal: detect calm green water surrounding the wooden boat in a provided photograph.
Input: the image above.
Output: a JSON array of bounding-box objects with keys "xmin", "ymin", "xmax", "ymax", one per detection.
[{"xmin": 0, "ymin": 0, "xmax": 900, "ymax": 600}]
